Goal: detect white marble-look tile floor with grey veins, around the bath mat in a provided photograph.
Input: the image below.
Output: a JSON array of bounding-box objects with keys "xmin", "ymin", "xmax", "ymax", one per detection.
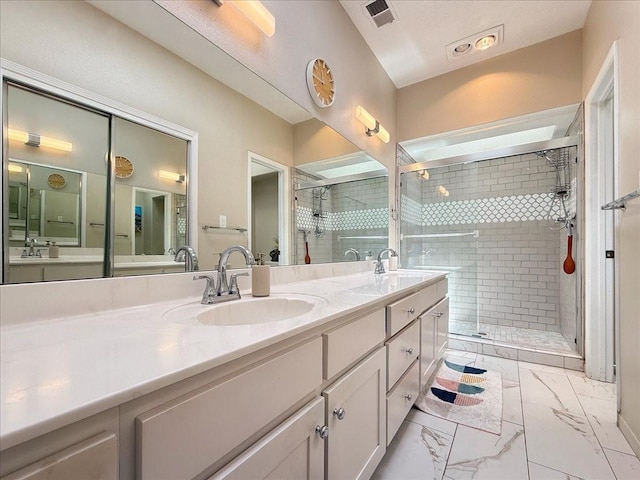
[{"xmin": 372, "ymin": 350, "xmax": 640, "ymax": 480}]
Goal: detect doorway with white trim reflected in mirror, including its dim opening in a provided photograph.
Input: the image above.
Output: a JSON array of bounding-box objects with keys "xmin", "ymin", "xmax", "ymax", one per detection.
[{"xmin": 247, "ymin": 152, "xmax": 290, "ymax": 265}]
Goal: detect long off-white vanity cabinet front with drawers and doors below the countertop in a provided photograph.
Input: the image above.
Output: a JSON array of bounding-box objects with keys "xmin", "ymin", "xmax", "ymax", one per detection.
[{"xmin": 0, "ymin": 274, "xmax": 448, "ymax": 480}]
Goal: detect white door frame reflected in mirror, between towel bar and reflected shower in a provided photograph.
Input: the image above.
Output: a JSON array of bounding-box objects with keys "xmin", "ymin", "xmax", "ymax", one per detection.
[{"xmin": 247, "ymin": 151, "xmax": 291, "ymax": 265}]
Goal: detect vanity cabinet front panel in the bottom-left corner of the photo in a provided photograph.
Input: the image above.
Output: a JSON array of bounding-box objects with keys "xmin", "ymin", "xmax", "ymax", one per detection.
[{"xmin": 2, "ymin": 433, "xmax": 118, "ymax": 480}]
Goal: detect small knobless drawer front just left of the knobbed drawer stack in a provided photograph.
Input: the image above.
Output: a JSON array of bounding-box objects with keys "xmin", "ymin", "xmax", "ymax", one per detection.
[{"xmin": 322, "ymin": 310, "xmax": 385, "ymax": 379}]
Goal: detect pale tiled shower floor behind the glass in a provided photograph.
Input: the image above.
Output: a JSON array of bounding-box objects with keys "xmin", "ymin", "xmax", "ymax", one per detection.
[{"xmin": 449, "ymin": 322, "xmax": 576, "ymax": 354}]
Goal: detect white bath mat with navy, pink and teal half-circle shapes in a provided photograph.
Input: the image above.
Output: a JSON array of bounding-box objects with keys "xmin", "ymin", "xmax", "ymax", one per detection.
[{"xmin": 415, "ymin": 360, "xmax": 502, "ymax": 435}]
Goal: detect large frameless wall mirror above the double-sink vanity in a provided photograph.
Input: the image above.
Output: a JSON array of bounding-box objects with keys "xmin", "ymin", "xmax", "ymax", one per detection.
[{"xmin": 0, "ymin": 1, "xmax": 388, "ymax": 282}]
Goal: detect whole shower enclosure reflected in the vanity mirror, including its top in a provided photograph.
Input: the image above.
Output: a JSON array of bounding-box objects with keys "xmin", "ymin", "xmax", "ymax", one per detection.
[{"xmin": 294, "ymin": 152, "xmax": 389, "ymax": 264}]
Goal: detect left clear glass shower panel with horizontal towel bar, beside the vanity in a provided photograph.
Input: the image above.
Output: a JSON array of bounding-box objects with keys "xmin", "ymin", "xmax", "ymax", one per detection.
[{"xmin": 400, "ymin": 163, "xmax": 484, "ymax": 337}]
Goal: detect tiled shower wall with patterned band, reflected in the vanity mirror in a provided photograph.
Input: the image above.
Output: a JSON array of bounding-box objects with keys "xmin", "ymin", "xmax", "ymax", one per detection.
[{"xmin": 294, "ymin": 171, "xmax": 389, "ymax": 264}]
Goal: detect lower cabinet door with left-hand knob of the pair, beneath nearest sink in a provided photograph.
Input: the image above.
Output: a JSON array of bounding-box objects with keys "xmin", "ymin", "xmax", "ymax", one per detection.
[{"xmin": 209, "ymin": 397, "xmax": 324, "ymax": 480}]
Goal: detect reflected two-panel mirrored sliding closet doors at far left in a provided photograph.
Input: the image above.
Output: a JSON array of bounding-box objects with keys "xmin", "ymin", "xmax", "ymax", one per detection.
[{"xmin": 3, "ymin": 82, "xmax": 188, "ymax": 283}]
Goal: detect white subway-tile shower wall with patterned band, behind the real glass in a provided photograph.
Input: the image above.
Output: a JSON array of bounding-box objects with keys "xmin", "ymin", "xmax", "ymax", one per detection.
[{"xmin": 402, "ymin": 154, "xmax": 566, "ymax": 331}]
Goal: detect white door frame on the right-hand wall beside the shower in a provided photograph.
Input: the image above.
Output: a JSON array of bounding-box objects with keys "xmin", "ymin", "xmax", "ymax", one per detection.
[{"xmin": 584, "ymin": 41, "xmax": 620, "ymax": 382}]
